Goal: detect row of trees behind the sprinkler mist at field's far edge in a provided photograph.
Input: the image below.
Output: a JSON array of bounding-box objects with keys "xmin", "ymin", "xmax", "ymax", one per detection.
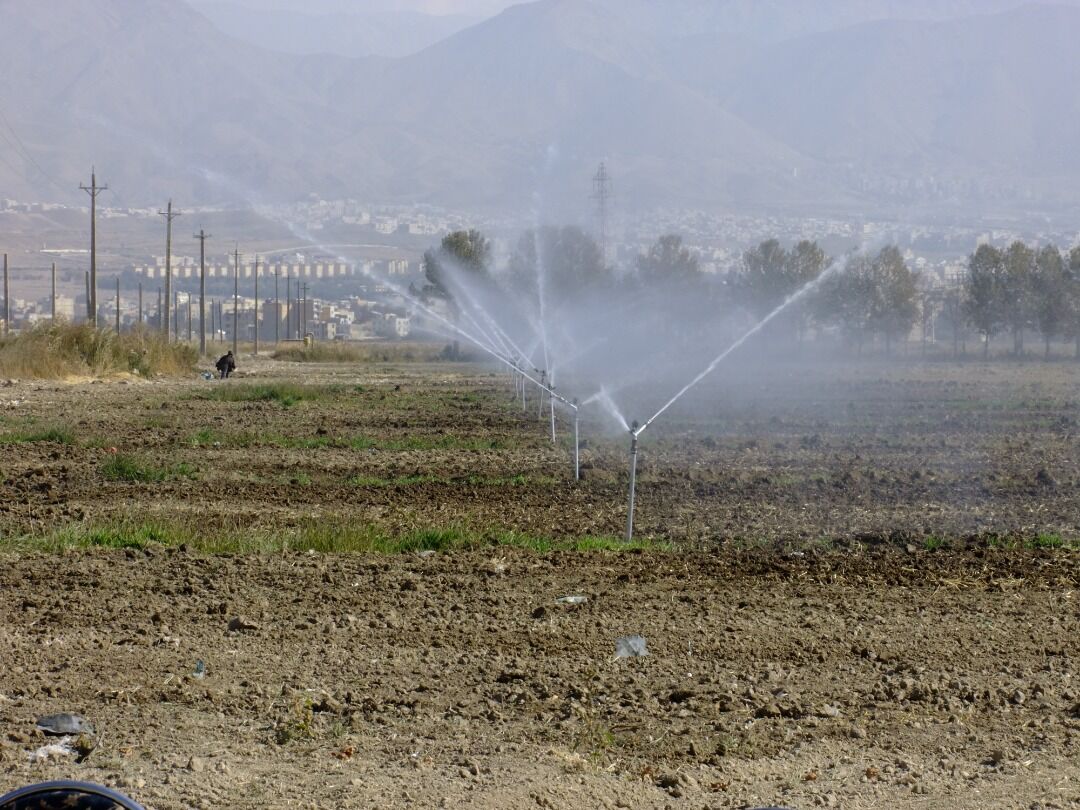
[{"xmin": 414, "ymin": 226, "xmax": 1080, "ymax": 359}]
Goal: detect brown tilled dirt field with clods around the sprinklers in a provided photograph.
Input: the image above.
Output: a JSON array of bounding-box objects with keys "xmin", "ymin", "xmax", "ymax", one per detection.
[{"xmin": 0, "ymin": 363, "xmax": 1080, "ymax": 810}]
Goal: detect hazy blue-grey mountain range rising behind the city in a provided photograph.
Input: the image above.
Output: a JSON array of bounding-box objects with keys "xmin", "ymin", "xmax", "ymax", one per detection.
[{"xmin": 0, "ymin": 0, "xmax": 1080, "ymax": 219}]
